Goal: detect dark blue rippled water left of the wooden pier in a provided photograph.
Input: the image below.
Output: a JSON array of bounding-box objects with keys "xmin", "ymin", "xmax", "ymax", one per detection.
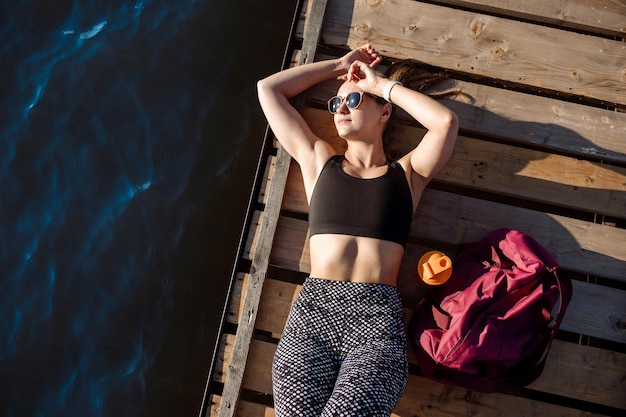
[{"xmin": 0, "ymin": 0, "xmax": 293, "ymax": 417}]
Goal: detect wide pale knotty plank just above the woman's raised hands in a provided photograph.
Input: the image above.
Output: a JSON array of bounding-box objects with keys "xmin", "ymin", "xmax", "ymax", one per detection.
[{"xmin": 322, "ymin": 0, "xmax": 626, "ymax": 105}]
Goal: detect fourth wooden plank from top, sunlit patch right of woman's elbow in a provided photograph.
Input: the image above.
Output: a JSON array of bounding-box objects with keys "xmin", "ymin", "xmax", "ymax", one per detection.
[{"xmin": 296, "ymin": 108, "xmax": 626, "ymax": 217}]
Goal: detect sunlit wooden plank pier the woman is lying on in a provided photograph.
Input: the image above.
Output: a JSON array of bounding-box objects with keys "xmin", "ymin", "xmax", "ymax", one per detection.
[{"xmin": 202, "ymin": 0, "xmax": 626, "ymax": 417}]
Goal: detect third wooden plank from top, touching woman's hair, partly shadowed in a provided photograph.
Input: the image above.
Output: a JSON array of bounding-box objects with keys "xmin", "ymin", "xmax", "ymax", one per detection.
[{"xmin": 309, "ymin": 75, "xmax": 626, "ymax": 164}]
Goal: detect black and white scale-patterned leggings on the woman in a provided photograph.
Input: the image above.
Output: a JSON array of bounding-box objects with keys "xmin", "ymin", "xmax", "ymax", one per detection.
[{"xmin": 272, "ymin": 278, "xmax": 408, "ymax": 417}]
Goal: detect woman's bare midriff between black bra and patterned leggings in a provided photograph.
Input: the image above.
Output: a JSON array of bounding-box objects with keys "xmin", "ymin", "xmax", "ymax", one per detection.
[{"xmin": 310, "ymin": 234, "xmax": 404, "ymax": 287}]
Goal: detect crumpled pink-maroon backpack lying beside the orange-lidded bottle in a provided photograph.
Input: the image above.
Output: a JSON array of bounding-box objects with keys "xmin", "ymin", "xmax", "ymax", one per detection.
[{"xmin": 409, "ymin": 229, "xmax": 572, "ymax": 392}]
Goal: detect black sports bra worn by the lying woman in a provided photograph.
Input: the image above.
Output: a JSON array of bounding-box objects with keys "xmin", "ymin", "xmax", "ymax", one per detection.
[{"xmin": 309, "ymin": 155, "xmax": 413, "ymax": 246}]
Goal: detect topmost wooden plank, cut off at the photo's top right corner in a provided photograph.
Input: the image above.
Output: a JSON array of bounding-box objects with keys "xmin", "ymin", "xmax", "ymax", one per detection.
[{"xmin": 439, "ymin": 0, "xmax": 626, "ymax": 37}]
